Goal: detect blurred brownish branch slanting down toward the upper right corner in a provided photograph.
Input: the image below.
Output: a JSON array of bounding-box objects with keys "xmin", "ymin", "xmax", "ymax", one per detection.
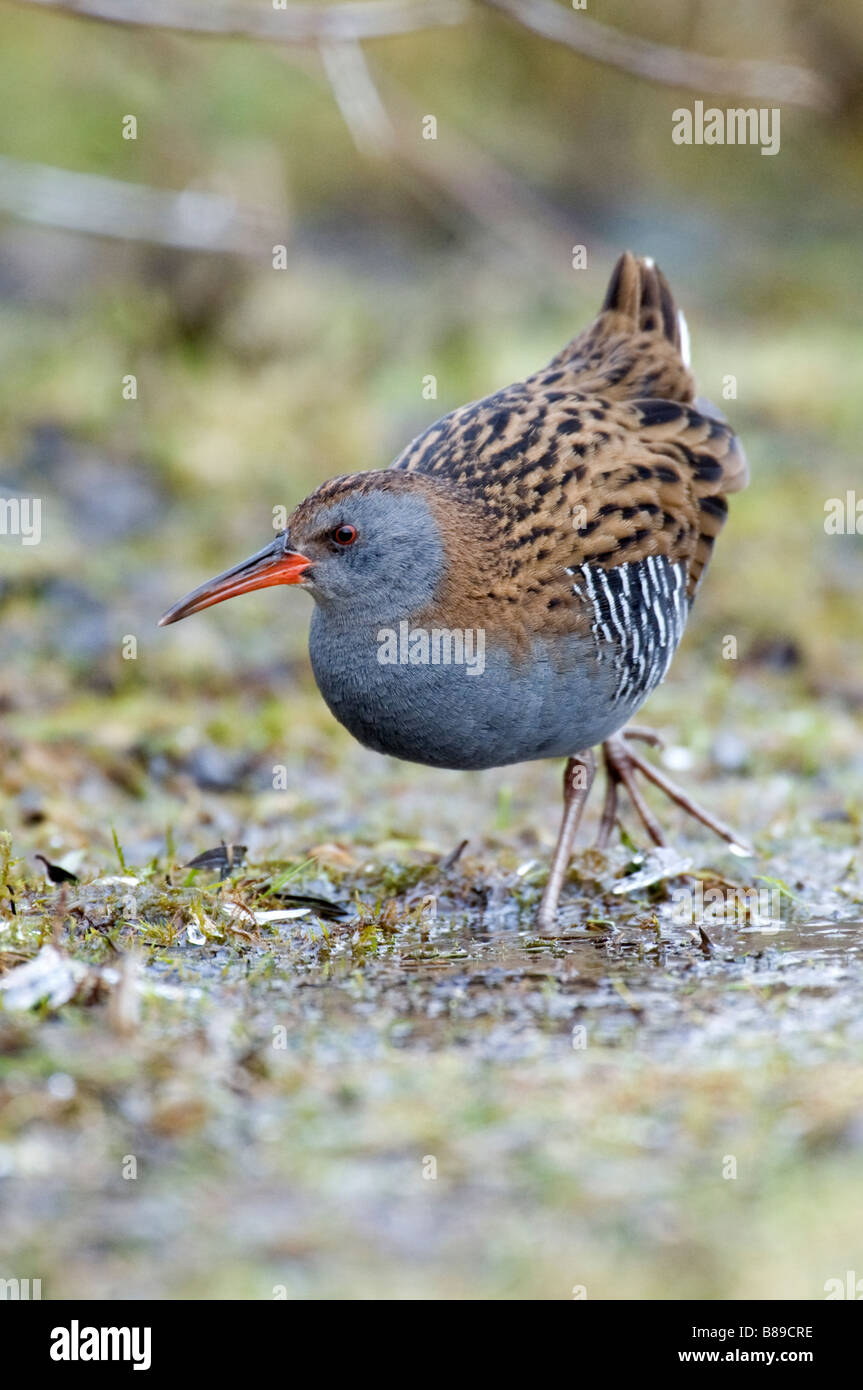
[{"xmin": 479, "ymin": 0, "xmax": 837, "ymax": 111}]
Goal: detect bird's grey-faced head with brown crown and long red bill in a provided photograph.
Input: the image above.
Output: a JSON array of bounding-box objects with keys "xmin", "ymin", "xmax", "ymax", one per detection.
[{"xmin": 154, "ymin": 470, "xmax": 464, "ymax": 627}]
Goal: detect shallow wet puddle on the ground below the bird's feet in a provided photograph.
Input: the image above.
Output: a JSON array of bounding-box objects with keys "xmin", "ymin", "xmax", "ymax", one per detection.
[{"xmin": 250, "ymin": 912, "xmax": 863, "ymax": 1062}]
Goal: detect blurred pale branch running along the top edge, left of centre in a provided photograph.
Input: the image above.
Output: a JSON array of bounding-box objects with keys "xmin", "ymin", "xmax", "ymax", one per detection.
[{"xmin": 15, "ymin": 0, "xmax": 468, "ymax": 43}]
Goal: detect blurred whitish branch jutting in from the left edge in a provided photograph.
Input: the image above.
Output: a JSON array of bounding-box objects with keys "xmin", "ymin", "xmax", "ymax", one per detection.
[{"xmin": 0, "ymin": 156, "xmax": 277, "ymax": 254}]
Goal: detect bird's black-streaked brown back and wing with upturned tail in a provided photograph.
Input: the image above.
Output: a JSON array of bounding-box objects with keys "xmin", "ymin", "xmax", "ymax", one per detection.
[{"xmin": 393, "ymin": 253, "xmax": 746, "ymax": 596}]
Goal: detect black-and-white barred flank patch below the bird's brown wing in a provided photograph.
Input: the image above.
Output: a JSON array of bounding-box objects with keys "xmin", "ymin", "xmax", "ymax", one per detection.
[{"xmin": 567, "ymin": 555, "xmax": 689, "ymax": 703}]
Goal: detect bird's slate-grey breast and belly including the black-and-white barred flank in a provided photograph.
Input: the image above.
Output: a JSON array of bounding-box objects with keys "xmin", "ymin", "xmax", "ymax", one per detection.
[{"xmin": 310, "ymin": 560, "xmax": 687, "ymax": 769}]
